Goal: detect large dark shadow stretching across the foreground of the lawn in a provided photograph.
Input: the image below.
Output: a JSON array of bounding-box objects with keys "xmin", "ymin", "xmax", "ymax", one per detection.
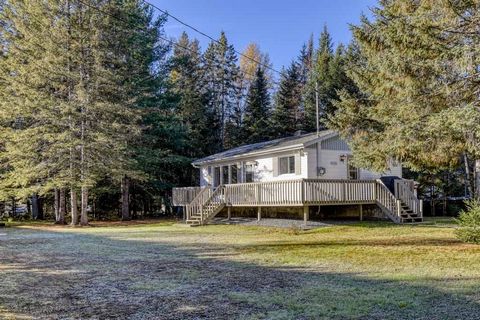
[{"xmin": 0, "ymin": 229, "xmax": 480, "ymax": 319}]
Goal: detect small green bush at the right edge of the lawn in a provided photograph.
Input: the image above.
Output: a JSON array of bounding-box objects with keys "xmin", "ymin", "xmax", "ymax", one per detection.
[{"xmin": 456, "ymin": 200, "xmax": 480, "ymax": 244}]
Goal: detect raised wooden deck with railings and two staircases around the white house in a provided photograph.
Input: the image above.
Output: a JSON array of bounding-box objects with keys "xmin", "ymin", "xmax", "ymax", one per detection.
[{"xmin": 173, "ymin": 179, "xmax": 423, "ymax": 225}]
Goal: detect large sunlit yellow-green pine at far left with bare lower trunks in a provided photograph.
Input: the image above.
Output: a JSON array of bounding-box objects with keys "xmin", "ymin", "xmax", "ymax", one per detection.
[{"xmin": 0, "ymin": 0, "xmax": 154, "ymax": 224}]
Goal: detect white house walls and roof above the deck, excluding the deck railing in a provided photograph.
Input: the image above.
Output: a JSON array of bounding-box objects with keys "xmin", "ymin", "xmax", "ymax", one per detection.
[{"xmin": 193, "ymin": 130, "xmax": 402, "ymax": 187}]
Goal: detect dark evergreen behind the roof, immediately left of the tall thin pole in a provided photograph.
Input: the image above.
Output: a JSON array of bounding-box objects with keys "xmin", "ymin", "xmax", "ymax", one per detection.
[{"xmin": 272, "ymin": 62, "xmax": 302, "ymax": 137}]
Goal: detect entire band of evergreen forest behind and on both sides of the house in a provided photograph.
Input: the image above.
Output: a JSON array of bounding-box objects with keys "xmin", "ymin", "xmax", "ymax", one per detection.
[{"xmin": 0, "ymin": 0, "xmax": 480, "ymax": 225}]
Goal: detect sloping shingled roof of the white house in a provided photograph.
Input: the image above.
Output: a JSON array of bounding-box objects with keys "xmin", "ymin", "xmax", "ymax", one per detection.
[{"xmin": 192, "ymin": 130, "xmax": 334, "ymax": 166}]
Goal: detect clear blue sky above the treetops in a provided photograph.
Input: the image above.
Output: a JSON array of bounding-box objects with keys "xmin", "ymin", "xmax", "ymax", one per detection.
[{"xmin": 154, "ymin": 0, "xmax": 377, "ymax": 69}]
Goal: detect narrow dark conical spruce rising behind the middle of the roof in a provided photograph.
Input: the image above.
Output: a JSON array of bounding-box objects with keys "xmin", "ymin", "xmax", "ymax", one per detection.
[{"xmin": 243, "ymin": 67, "xmax": 271, "ymax": 143}]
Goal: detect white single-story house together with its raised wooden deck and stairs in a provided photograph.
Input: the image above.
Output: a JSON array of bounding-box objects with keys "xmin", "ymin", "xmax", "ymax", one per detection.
[{"xmin": 173, "ymin": 130, "xmax": 422, "ymax": 225}]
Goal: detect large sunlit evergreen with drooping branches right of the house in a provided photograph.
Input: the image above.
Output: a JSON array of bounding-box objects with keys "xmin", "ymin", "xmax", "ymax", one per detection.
[{"xmin": 331, "ymin": 0, "xmax": 480, "ymax": 195}]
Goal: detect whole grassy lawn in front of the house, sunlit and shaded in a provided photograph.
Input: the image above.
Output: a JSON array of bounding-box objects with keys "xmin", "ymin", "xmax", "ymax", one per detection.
[{"xmin": 0, "ymin": 220, "xmax": 480, "ymax": 319}]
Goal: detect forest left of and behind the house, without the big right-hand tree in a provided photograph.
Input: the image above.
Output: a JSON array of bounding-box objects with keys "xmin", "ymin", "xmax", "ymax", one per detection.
[{"xmin": 0, "ymin": 0, "xmax": 354, "ymax": 224}]
